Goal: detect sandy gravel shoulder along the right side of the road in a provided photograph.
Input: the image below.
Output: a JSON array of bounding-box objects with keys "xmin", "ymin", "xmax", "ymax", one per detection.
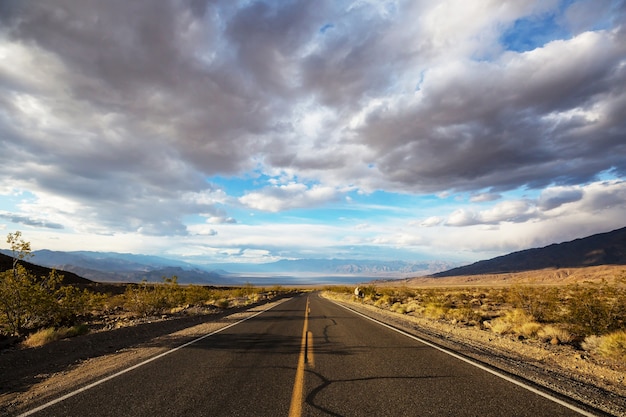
[{"xmin": 324, "ymin": 294, "xmax": 626, "ymax": 417}]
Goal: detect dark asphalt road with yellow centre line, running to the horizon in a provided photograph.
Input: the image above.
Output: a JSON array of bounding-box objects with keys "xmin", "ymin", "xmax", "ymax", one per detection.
[{"xmin": 18, "ymin": 294, "xmax": 596, "ymax": 417}]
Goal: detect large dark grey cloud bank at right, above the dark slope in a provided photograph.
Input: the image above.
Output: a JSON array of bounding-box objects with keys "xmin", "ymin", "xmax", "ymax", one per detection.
[{"xmin": 359, "ymin": 27, "xmax": 626, "ymax": 190}]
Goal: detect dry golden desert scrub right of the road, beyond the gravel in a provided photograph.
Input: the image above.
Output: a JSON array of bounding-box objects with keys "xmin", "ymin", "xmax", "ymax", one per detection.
[{"xmin": 326, "ymin": 270, "xmax": 626, "ymax": 363}]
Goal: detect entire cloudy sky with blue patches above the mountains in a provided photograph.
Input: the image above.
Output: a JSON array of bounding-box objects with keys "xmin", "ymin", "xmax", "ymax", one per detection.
[{"xmin": 0, "ymin": 0, "xmax": 626, "ymax": 262}]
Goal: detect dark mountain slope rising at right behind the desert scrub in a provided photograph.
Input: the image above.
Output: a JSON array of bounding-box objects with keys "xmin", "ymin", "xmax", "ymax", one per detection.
[{"xmin": 433, "ymin": 227, "xmax": 626, "ymax": 277}]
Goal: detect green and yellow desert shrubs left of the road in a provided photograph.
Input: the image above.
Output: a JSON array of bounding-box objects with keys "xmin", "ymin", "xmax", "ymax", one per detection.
[{"xmin": 0, "ymin": 231, "xmax": 291, "ymax": 347}]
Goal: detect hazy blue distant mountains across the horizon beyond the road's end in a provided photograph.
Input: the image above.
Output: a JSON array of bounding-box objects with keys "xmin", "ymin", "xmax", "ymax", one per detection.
[{"xmin": 0, "ymin": 250, "xmax": 458, "ymax": 285}]
